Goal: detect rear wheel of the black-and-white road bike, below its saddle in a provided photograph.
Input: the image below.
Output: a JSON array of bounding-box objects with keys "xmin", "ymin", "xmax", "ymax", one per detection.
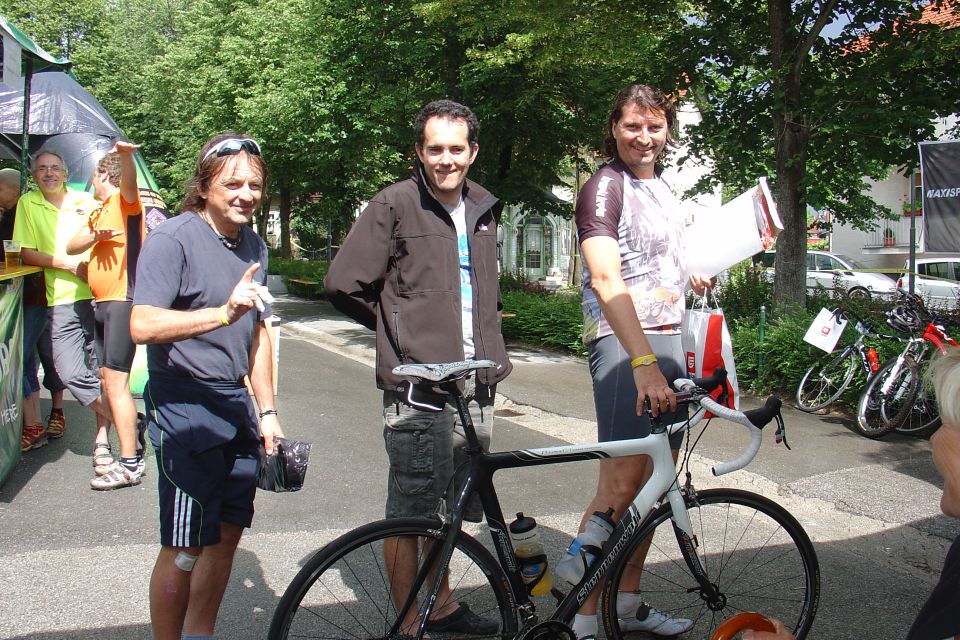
[{"xmin": 269, "ymin": 518, "xmax": 517, "ymax": 640}]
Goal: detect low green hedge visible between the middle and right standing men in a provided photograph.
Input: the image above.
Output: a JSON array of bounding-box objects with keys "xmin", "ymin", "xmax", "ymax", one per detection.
[{"xmin": 501, "ymin": 289, "xmax": 587, "ymax": 356}]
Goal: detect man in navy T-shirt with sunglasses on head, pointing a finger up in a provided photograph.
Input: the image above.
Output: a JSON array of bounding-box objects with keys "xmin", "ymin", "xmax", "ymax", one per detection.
[{"xmin": 130, "ymin": 134, "xmax": 283, "ymax": 640}]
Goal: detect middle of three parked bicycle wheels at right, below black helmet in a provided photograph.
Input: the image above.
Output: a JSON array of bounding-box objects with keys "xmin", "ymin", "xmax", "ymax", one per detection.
[{"xmin": 854, "ymin": 356, "xmax": 920, "ymax": 439}]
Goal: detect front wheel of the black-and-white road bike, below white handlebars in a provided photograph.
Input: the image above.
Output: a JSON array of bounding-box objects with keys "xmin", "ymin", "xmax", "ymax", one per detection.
[{"xmin": 601, "ymin": 489, "xmax": 820, "ymax": 640}]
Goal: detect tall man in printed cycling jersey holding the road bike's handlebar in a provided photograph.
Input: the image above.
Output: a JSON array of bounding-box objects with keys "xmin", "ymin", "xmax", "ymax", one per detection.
[{"xmin": 573, "ymin": 84, "xmax": 712, "ymax": 639}]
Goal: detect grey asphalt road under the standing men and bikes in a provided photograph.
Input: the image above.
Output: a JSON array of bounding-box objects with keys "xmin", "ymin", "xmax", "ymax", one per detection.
[{"xmin": 0, "ymin": 298, "xmax": 960, "ymax": 640}]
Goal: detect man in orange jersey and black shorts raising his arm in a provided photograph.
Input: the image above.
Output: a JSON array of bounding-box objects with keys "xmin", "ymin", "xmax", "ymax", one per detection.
[{"xmin": 67, "ymin": 141, "xmax": 146, "ymax": 491}]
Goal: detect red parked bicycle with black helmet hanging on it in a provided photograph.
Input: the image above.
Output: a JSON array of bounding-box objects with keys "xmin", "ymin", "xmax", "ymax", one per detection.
[{"xmin": 855, "ymin": 291, "xmax": 957, "ymax": 438}]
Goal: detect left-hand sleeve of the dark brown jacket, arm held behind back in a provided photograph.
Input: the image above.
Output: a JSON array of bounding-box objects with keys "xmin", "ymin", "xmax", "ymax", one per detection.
[{"xmin": 323, "ymin": 199, "xmax": 394, "ymax": 330}]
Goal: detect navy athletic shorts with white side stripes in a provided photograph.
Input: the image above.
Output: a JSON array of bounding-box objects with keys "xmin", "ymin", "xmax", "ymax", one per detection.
[{"xmin": 144, "ymin": 374, "xmax": 260, "ymax": 547}]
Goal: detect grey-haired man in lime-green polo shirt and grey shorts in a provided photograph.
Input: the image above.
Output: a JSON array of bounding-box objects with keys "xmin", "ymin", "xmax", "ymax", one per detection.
[{"xmin": 13, "ymin": 150, "xmax": 115, "ymax": 474}]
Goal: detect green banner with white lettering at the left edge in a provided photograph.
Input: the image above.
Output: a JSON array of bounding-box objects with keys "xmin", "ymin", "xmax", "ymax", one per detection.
[{"xmin": 0, "ymin": 278, "xmax": 23, "ymax": 484}]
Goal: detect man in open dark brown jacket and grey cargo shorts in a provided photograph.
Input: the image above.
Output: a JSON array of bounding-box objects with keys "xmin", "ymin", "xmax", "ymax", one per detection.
[{"xmin": 324, "ymin": 100, "xmax": 511, "ymax": 634}]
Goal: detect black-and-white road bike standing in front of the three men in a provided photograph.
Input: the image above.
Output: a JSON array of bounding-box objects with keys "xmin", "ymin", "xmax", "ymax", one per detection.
[{"xmin": 269, "ymin": 360, "xmax": 820, "ymax": 640}]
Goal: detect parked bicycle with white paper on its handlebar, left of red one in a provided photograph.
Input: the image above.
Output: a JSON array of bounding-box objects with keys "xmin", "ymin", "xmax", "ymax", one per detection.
[{"xmin": 796, "ymin": 306, "xmax": 899, "ymax": 413}]
